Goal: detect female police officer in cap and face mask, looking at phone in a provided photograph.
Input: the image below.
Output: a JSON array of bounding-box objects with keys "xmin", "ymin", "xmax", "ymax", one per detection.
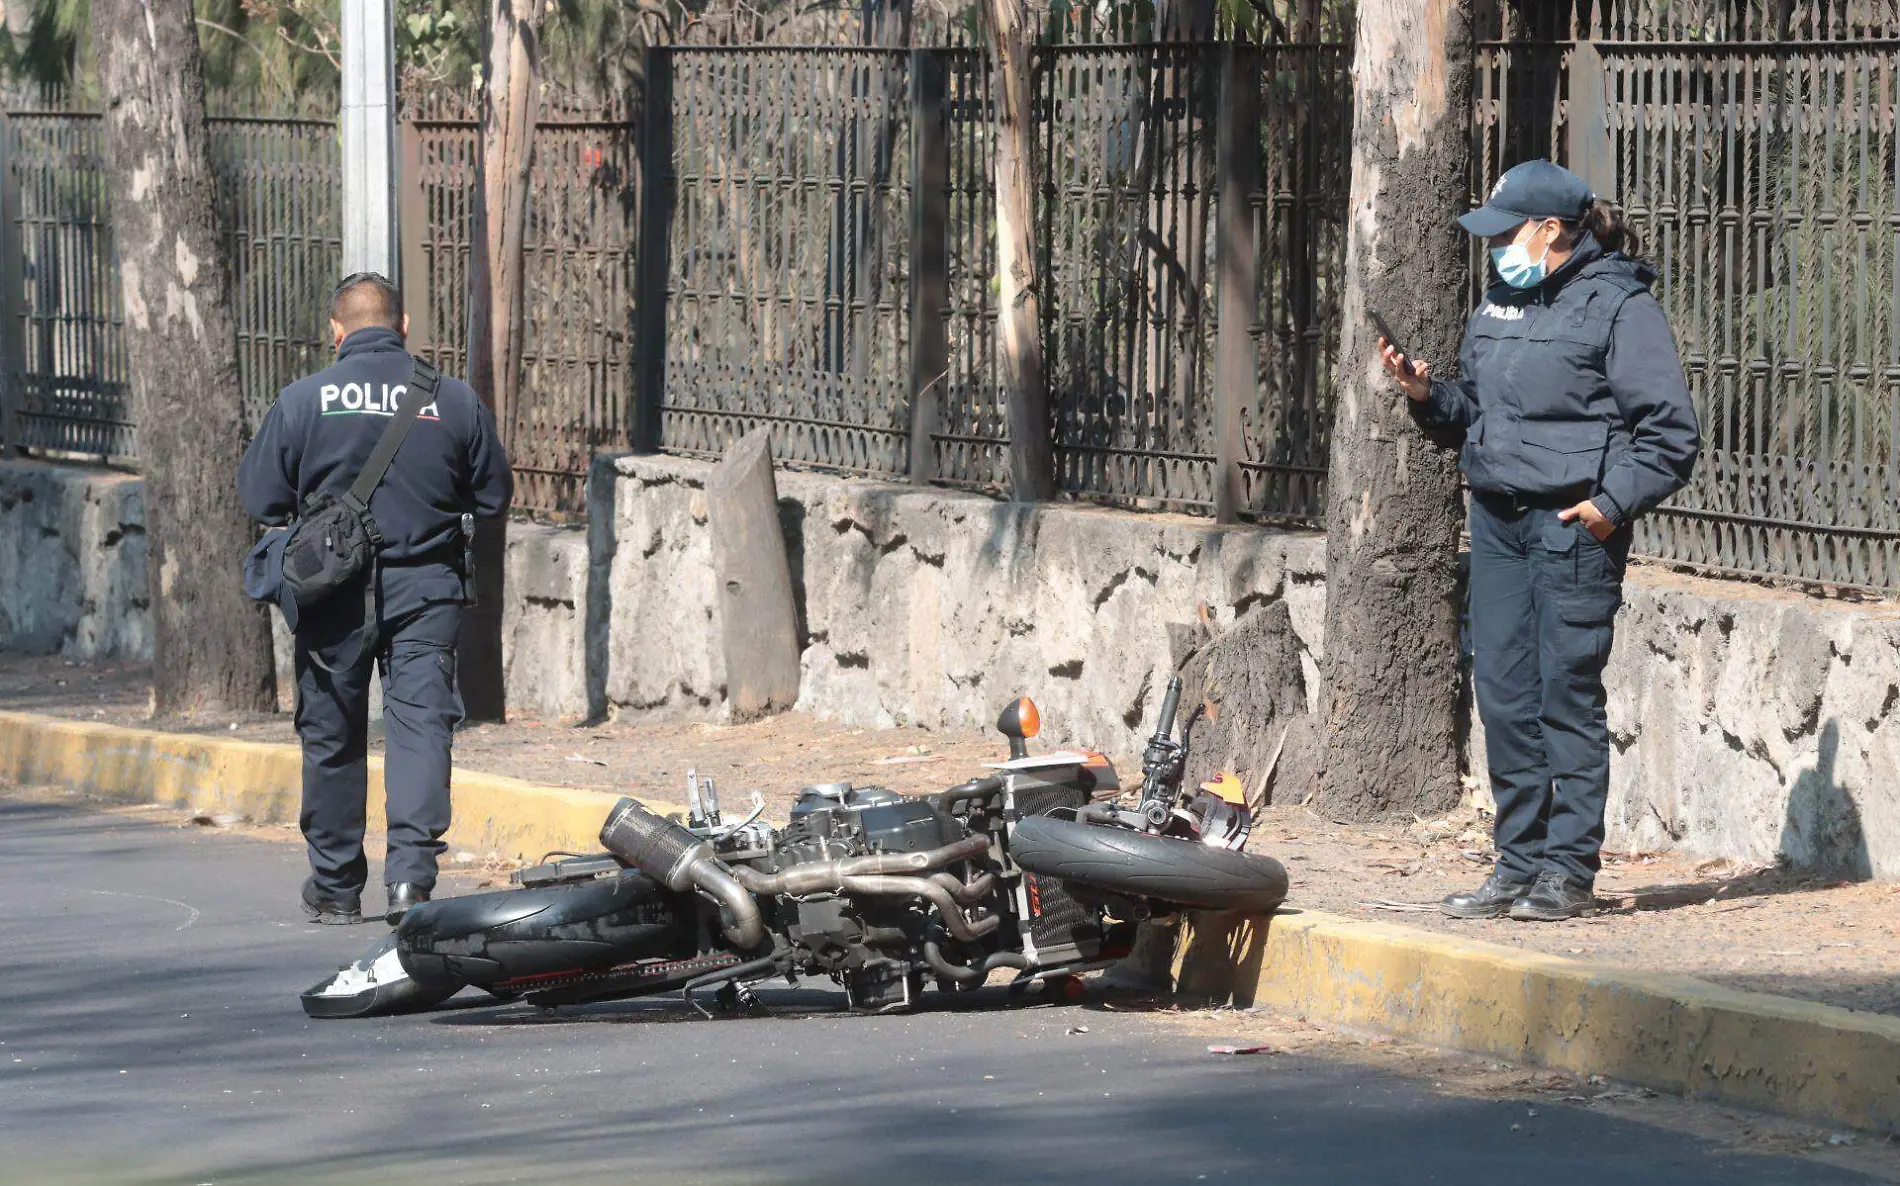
[{"xmin": 1381, "ymin": 162, "xmax": 1701, "ymax": 920}]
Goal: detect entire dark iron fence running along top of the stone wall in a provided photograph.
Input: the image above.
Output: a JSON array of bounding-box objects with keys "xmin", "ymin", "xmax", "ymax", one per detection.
[{"xmin": 0, "ymin": 4, "xmax": 1900, "ymax": 589}]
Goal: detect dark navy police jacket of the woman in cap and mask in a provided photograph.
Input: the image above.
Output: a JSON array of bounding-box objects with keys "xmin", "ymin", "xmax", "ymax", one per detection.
[{"xmin": 1410, "ymin": 234, "xmax": 1701, "ymax": 526}]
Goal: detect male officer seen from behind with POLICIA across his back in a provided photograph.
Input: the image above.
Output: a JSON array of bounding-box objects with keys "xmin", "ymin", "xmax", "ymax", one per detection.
[{"xmin": 238, "ymin": 272, "xmax": 513, "ymax": 926}]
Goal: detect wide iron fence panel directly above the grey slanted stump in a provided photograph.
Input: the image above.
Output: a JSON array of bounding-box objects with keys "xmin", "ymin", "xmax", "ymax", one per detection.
[{"xmin": 642, "ymin": 48, "xmax": 915, "ymax": 475}]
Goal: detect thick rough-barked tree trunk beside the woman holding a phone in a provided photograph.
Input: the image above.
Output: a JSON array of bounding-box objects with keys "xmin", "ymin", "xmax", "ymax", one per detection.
[{"xmin": 1317, "ymin": 0, "xmax": 1473, "ymax": 819}]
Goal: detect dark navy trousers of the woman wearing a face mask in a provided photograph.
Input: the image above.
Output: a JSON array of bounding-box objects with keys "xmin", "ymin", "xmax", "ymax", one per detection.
[{"xmin": 1471, "ymin": 494, "xmax": 1630, "ymax": 886}]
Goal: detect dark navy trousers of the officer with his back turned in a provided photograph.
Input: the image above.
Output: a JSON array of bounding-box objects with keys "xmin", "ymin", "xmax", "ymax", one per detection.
[{"xmin": 296, "ymin": 589, "xmax": 462, "ymax": 893}]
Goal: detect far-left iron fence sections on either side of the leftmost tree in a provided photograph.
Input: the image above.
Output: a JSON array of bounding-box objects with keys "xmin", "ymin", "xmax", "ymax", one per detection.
[{"xmin": 0, "ymin": 110, "xmax": 342, "ymax": 460}]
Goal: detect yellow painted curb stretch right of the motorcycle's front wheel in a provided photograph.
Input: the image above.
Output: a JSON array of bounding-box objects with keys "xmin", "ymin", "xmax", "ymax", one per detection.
[{"xmin": 1176, "ymin": 910, "xmax": 1900, "ymax": 1133}]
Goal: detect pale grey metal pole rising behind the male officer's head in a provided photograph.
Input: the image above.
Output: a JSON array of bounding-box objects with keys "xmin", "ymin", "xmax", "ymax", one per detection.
[{"xmin": 340, "ymin": 0, "xmax": 399, "ymax": 279}]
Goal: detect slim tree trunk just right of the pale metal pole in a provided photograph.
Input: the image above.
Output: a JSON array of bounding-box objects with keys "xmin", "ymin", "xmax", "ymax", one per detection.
[{"xmin": 458, "ymin": 0, "xmax": 547, "ymax": 720}]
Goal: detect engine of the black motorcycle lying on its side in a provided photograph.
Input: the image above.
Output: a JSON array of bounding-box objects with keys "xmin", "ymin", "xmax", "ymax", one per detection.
[{"xmin": 773, "ymin": 783, "xmax": 965, "ymax": 1009}]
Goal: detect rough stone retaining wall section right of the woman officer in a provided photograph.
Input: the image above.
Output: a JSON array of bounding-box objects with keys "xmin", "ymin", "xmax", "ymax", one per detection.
[{"xmin": 1603, "ymin": 568, "xmax": 1900, "ymax": 878}]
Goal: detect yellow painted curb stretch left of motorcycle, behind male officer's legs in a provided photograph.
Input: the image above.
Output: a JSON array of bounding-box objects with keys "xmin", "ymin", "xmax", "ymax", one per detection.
[{"xmin": 0, "ymin": 713, "xmax": 678, "ymax": 859}]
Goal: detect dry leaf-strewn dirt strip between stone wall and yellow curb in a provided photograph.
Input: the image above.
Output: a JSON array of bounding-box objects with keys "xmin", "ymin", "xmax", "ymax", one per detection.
[{"xmin": 0, "ymin": 656, "xmax": 1900, "ymax": 1013}]
